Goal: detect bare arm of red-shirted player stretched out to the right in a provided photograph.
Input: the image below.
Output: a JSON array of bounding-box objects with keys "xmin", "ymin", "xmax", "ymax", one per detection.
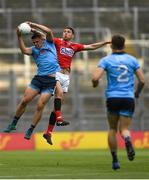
[{"xmin": 84, "ymin": 41, "xmax": 111, "ymax": 50}]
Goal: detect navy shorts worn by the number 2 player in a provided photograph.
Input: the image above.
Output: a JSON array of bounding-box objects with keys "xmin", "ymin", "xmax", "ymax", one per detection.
[{"xmin": 106, "ymin": 98, "xmax": 135, "ymax": 117}]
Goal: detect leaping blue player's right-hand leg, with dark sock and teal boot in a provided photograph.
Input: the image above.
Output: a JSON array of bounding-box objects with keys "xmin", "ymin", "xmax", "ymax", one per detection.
[{"xmin": 24, "ymin": 93, "xmax": 51, "ymax": 140}]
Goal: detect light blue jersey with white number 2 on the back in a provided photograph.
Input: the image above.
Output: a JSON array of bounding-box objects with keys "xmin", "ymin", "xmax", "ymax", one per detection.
[{"xmin": 98, "ymin": 53, "xmax": 140, "ymax": 98}]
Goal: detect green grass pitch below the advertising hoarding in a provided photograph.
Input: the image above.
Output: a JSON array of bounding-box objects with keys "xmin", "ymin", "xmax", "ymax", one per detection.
[{"xmin": 0, "ymin": 150, "xmax": 149, "ymax": 179}]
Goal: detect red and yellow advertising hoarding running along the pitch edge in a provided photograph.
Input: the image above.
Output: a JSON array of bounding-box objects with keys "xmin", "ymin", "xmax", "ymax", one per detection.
[{"xmin": 0, "ymin": 131, "xmax": 149, "ymax": 151}]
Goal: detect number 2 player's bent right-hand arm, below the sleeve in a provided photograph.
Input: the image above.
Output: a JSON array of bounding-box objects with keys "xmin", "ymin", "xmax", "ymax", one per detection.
[{"xmin": 135, "ymin": 68, "xmax": 145, "ymax": 98}]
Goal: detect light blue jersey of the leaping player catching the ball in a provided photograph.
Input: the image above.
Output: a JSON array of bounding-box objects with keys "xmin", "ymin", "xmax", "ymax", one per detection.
[{"xmin": 32, "ymin": 40, "xmax": 60, "ymax": 76}]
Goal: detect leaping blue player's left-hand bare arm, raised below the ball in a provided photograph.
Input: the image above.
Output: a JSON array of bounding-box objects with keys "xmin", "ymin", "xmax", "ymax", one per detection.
[{"xmin": 16, "ymin": 28, "xmax": 32, "ymax": 55}]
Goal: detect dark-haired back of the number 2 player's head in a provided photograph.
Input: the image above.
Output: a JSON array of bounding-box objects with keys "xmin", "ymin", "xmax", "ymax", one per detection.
[{"xmin": 112, "ymin": 34, "xmax": 125, "ymax": 50}]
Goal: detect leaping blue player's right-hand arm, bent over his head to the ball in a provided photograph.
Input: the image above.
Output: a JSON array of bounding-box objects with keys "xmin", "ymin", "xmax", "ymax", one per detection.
[{"xmin": 28, "ymin": 22, "xmax": 54, "ymax": 42}]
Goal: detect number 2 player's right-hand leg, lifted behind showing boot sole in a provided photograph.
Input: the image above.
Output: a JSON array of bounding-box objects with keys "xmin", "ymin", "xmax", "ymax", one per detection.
[{"xmin": 119, "ymin": 116, "xmax": 135, "ymax": 161}]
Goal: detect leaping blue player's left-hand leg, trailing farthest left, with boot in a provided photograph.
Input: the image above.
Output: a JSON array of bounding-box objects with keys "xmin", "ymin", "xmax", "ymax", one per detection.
[{"xmin": 4, "ymin": 87, "xmax": 38, "ymax": 133}]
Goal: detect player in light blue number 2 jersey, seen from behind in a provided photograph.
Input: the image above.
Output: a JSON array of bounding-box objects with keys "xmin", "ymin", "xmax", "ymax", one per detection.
[{"xmin": 92, "ymin": 35, "xmax": 145, "ymax": 170}]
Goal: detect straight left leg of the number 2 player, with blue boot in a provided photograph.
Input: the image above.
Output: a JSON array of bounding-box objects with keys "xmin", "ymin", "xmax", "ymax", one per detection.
[{"xmin": 108, "ymin": 114, "xmax": 120, "ymax": 170}]
